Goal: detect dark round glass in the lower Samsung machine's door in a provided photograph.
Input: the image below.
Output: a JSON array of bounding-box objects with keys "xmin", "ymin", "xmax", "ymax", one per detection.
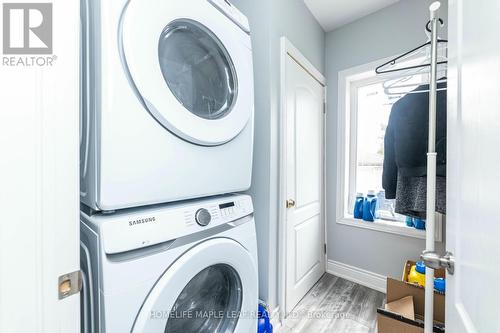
[{"xmin": 165, "ymin": 264, "xmax": 243, "ymax": 333}]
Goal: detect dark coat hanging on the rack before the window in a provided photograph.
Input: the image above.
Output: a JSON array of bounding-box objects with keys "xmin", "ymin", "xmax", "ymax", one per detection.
[{"xmin": 382, "ymin": 82, "xmax": 446, "ymax": 218}]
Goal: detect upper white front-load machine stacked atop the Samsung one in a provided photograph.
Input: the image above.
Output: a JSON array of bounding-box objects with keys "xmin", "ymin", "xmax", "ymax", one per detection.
[{"xmin": 80, "ymin": 0, "xmax": 254, "ymax": 211}]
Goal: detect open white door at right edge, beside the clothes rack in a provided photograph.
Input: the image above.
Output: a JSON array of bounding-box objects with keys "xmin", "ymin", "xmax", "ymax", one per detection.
[{"xmin": 446, "ymin": 0, "xmax": 500, "ymax": 333}]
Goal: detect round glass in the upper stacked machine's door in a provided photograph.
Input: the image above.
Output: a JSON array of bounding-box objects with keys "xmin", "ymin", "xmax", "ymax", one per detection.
[{"xmin": 158, "ymin": 19, "xmax": 238, "ymax": 119}]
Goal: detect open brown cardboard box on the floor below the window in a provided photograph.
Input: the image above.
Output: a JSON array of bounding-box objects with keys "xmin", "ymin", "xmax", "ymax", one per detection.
[{"xmin": 377, "ymin": 261, "xmax": 446, "ymax": 333}]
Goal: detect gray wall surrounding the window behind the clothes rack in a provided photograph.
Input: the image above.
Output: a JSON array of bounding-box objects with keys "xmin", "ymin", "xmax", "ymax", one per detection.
[{"xmin": 325, "ymin": 0, "xmax": 447, "ymax": 278}]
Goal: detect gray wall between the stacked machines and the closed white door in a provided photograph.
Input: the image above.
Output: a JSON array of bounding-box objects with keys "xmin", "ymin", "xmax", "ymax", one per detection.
[{"xmin": 231, "ymin": 0, "xmax": 325, "ymax": 307}]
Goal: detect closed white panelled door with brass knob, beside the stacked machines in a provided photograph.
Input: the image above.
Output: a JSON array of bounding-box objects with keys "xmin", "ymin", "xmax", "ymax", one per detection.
[{"xmin": 284, "ymin": 48, "xmax": 325, "ymax": 313}]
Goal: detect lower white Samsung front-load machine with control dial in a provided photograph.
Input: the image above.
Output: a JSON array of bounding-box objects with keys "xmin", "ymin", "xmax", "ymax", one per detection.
[{"xmin": 81, "ymin": 195, "xmax": 258, "ymax": 333}]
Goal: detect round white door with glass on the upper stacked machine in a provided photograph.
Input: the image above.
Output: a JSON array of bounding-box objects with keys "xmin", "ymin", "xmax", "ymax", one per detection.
[{"xmin": 121, "ymin": 0, "xmax": 253, "ymax": 145}]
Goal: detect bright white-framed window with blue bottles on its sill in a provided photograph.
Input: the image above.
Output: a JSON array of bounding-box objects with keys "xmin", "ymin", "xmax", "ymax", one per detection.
[{"xmin": 337, "ymin": 60, "xmax": 441, "ymax": 240}]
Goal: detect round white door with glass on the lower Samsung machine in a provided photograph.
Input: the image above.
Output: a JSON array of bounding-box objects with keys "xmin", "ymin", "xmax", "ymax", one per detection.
[{"xmin": 132, "ymin": 238, "xmax": 258, "ymax": 333}]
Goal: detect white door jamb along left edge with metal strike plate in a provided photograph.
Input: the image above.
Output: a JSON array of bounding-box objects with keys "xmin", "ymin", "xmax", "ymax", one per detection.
[{"xmin": 0, "ymin": 0, "xmax": 80, "ymax": 333}]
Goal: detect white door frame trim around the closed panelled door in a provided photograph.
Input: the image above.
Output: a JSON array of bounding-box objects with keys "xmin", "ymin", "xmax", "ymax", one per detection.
[{"xmin": 276, "ymin": 36, "xmax": 327, "ymax": 323}]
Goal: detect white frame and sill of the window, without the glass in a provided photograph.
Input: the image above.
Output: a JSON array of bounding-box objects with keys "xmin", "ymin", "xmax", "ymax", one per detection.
[{"xmin": 336, "ymin": 57, "xmax": 443, "ymax": 242}]
